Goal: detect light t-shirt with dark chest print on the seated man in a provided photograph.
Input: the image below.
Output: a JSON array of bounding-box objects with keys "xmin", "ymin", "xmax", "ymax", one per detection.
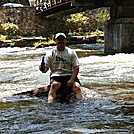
[{"xmin": 45, "ymin": 47, "xmax": 80, "ymax": 77}]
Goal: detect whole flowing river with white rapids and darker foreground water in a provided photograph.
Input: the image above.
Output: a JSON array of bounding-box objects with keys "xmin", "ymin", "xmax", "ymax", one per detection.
[{"xmin": 0, "ymin": 45, "xmax": 134, "ymax": 134}]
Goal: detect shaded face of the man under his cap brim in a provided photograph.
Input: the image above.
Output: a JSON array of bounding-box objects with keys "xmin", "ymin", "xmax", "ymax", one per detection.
[{"xmin": 55, "ymin": 36, "xmax": 66, "ymax": 51}]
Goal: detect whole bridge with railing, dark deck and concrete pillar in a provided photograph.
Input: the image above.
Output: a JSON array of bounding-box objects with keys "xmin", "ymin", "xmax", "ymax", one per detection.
[{"xmin": 32, "ymin": 0, "xmax": 134, "ymax": 54}]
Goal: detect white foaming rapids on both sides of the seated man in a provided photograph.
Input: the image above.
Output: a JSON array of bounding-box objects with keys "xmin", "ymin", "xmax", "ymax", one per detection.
[{"xmin": 0, "ymin": 47, "xmax": 134, "ymax": 101}]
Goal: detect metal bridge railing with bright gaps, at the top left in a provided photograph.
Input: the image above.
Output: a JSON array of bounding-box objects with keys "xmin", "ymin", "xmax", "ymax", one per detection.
[{"xmin": 34, "ymin": 0, "xmax": 71, "ymax": 13}]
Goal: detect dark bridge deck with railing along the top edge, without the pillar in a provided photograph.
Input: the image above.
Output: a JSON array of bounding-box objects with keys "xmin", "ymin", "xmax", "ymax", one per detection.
[{"xmin": 35, "ymin": 0, "xmax": 133, "ymax": 16}]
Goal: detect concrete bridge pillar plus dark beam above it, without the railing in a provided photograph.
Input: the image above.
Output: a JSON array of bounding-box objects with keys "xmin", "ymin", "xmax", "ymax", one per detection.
[{"xmin": 72, "ymin": 0, "xmax": 134, "ymax": 54}]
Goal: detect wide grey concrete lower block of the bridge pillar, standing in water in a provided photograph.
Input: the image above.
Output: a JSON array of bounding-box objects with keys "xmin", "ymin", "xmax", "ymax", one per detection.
[{"xmin": 105, "ymin": 18, "xmax": 134, "ymax": 54}]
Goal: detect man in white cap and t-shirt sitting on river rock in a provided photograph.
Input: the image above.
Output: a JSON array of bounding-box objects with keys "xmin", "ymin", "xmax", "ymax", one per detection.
[{"xmin": 40, "ymin": 33, "xmax": 82, "ymax": 101}]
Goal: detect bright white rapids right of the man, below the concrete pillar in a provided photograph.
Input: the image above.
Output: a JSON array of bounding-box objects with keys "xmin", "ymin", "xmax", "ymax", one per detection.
[{"xmin": 80, "ymin": 54, "xmax": 134, "ymax": 83}]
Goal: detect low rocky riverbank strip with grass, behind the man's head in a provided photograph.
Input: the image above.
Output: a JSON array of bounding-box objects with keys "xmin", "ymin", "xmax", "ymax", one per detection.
[{"xmin": 0, "ymin": 35, "xmax": 104, "ymax": 48}]
